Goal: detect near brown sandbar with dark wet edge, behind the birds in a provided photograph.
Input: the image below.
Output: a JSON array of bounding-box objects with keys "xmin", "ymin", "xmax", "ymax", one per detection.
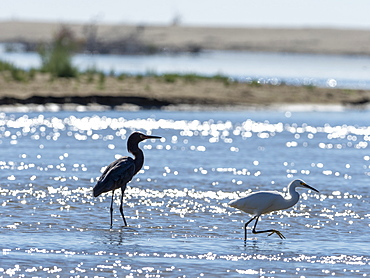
[{"xmin": 0, "ymin": 74, "xmax": 370, "ymax": 108}]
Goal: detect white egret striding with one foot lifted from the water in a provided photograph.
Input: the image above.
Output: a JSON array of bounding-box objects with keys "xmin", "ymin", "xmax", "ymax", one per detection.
[{"xmin": 229, "ymin": 180, "xmax": 319, "ymax": 241}]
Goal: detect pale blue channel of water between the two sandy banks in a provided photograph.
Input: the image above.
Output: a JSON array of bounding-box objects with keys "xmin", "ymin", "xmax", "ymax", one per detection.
[{"xmin": 0, "ymin": 49, "xmax": 370, "ymax": 89}]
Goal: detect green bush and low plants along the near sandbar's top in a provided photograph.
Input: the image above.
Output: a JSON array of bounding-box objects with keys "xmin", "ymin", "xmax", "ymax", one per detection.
[{"xmin": 0, "ymin": 24, "xmax": 234, "ymax": 87}]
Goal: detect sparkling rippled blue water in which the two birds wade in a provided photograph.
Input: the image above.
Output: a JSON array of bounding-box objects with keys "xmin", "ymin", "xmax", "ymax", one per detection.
[{"xmin": 0, "ymin": 111, "xmax": 370, "ymax": 277}]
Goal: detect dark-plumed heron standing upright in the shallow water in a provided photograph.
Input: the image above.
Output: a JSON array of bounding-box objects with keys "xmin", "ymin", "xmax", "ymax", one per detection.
[{"xmin": 93, "ymin": 132, "xmax": 162, "ymax": 228}]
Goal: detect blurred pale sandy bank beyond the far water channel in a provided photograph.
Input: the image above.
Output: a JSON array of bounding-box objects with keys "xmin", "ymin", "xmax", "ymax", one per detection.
[{"xmin": 0, "ymin": 21, "xmax": 370, "ymax": 55}]
